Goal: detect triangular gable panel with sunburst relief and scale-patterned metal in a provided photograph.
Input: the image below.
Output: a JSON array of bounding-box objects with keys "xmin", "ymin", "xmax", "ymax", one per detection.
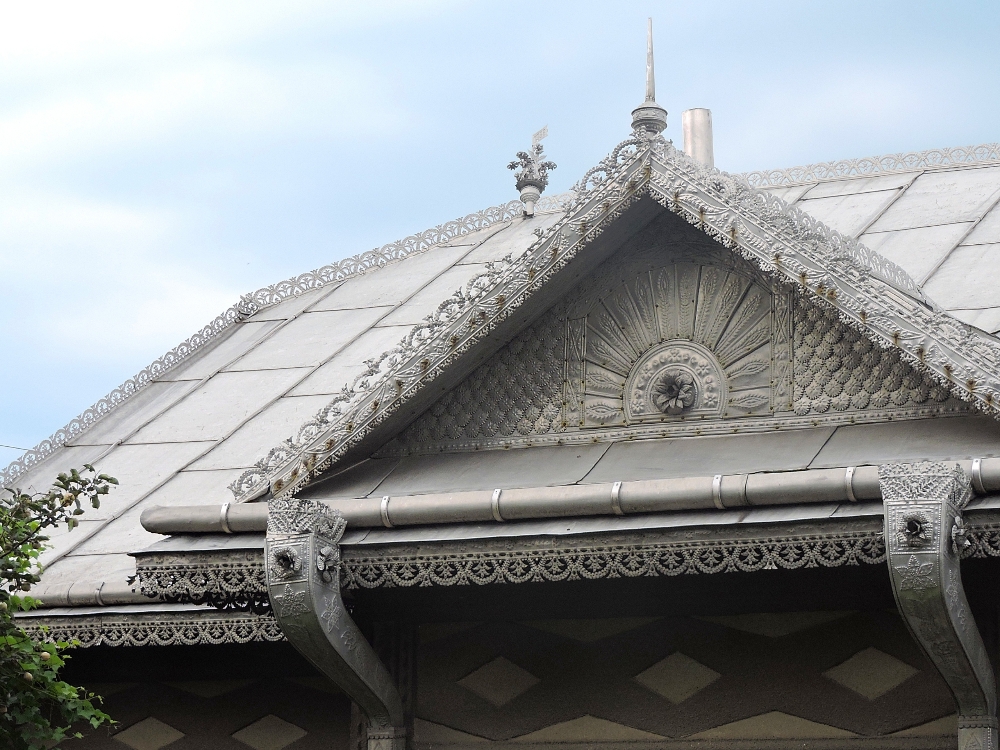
[{"xmin": 388, "ymin": 214, "xmax": 968, "ymax": 455}]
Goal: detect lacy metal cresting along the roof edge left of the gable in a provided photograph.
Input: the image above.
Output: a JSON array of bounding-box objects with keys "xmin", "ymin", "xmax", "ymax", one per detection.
[{"xmin": 0, "ymin": 198, "xmax": 548, "ymax": 488}]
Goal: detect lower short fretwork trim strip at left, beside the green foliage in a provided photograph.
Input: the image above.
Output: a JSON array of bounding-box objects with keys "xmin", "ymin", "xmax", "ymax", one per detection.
[{"xmin": 18, "ymin": 610, "xmax": 285, "ymax": 648}]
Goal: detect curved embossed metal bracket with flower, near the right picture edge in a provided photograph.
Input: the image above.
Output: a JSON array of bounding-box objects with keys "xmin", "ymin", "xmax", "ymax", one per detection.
[{"xmin": 879, "ymin": 463, "xmax": 997, "ymax": 750}]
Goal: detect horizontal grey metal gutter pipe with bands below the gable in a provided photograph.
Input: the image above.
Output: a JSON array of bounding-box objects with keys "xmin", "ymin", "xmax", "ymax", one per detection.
[{"xmin": 140, "ymin": 458, "xmax": 1000, "ymax": 534}]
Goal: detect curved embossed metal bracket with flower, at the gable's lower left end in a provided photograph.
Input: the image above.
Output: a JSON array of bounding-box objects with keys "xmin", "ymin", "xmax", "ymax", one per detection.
[{"xmin": 264, "ymin": 498, "xmax": 406, "ymax": 750}]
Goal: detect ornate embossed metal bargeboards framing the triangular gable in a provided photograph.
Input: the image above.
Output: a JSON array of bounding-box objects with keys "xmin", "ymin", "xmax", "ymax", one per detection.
[{"xmin": 232, "ymin": 136, "xmax": 1000, "ymax": 500}]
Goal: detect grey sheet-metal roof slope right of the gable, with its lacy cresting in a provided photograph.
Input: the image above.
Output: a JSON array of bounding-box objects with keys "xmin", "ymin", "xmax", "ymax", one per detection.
[{"xmin": 744, "ymin": 143, "xmax": 1000, "ymax": 333}]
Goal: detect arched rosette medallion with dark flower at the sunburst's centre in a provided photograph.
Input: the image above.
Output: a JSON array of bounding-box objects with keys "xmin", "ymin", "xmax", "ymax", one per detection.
[{"xmin": 625, "ymin": 341, "xmax": 726, "ymax": 422}]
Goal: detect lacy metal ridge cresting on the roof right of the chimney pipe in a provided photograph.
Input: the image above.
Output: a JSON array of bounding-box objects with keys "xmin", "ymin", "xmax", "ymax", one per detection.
[{"xmin": 734, "ymin": 143, "xmax": 1000, "ymax": 188}]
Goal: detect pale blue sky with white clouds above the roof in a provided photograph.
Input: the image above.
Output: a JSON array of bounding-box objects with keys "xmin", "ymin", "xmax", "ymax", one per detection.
[{"xmin": 0, "ymin": 0, "xmax": 1000, "ymax": 465}]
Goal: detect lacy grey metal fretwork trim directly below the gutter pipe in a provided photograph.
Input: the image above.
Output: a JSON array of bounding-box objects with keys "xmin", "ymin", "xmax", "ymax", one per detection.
[{"xmin": 129, "ymin": 519, "xmax": 1000, "ymax": 609}]
